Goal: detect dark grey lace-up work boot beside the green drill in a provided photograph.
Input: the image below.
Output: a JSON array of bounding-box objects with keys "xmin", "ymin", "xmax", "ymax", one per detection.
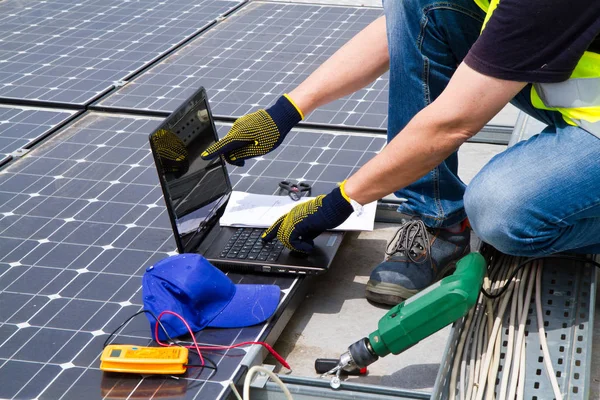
[{"xmin": 366, "ymin": 219, "xmax": 471, "ymax": 305}]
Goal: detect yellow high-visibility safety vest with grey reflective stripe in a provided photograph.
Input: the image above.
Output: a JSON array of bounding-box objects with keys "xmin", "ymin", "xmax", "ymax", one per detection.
[{"xmin": 474, "ymin": 0, "xmax": 600, "ymax": 138}]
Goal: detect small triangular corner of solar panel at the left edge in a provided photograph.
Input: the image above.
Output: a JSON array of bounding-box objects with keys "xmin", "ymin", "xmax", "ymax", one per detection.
[{"xmin": 0, "ymin": 106, "xmax": 77, "ymax": 165}]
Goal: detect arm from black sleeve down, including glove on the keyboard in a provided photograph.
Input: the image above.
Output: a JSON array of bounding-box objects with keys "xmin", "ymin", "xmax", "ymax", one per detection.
[{"xmin": 264, "ymin": 64, "xmax": 525, "ymax": 252}]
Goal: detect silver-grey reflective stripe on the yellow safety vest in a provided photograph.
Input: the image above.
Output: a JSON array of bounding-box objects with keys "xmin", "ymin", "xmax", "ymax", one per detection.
[{"xmin": 534, "ymin": 78, "xmax": 600, "ymax": 108}]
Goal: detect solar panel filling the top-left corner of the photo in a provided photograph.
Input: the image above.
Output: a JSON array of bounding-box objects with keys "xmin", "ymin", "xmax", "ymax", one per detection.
[{"xmin": 0, "ymin": 0, "xmax": 243, "ymax": 105}]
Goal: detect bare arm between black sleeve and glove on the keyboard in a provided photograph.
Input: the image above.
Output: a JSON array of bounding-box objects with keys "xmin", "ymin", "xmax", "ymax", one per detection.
[{"xmin": 345, "ymin": 63, "xmax": 526, "ymax": 204}]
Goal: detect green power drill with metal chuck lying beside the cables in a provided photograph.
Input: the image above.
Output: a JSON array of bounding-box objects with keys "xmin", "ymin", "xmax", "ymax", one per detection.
[{"xmin": 325, "ymin": 253, "xmax": 486, "ymax": 388}]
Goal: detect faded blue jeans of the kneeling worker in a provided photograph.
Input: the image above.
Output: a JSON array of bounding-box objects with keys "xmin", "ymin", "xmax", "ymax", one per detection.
[{"xmin": 383, "ymin": 0, "xmax": 600, "ymax": 256}]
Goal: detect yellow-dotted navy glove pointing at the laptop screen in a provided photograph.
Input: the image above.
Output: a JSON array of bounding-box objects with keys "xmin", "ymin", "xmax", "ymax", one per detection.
[{"xmin": 201, "ymin": 94, "xmax": 304, "ymax": 167}]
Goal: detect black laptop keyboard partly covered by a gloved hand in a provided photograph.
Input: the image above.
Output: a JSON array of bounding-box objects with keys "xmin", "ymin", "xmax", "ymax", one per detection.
[{"xmin": 220, "ymin": 228, "xmax": 283, "ymax": 262}]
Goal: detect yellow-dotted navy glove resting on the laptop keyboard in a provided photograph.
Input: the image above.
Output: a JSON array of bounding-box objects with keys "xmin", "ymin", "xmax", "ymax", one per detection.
[{"xmin": 262, "ymin": 181, "xmax": 354, "ymax": 253}]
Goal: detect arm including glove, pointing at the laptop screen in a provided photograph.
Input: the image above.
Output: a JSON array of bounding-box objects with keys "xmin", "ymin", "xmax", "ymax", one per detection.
[{"xmin": 202, "ymin": 17, "xmax": 389, "ymax": 166}]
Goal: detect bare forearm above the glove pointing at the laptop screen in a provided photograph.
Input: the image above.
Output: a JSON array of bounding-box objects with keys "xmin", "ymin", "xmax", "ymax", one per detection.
[{"xmin": 289, "ymin": 17, "xmax": 389, "ymax": 115}]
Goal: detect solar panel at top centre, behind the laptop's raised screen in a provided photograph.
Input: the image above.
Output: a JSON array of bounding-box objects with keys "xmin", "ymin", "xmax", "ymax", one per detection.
[{"xmin": 98, "ymin": 2, "xmax": 388, "ymax": 129}]
